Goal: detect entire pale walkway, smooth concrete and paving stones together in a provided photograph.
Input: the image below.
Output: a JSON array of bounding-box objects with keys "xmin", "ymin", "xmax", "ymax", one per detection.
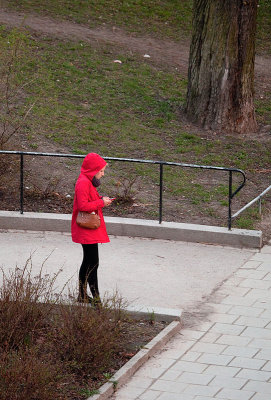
[{"xmin": 0, "ymin": 230, "xmax": 271, "ymax": 400}]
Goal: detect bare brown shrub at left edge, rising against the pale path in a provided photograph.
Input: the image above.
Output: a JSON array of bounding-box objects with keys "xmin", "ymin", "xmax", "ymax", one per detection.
[{"xmin": 0, "ymin": 258, "xmax": 60, "ymax": 350}]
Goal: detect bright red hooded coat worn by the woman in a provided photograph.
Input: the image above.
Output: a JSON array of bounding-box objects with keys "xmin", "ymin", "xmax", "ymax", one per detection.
[{"xmin": 71, "ymin": 153, "xmax": 110, "ymax": 244}]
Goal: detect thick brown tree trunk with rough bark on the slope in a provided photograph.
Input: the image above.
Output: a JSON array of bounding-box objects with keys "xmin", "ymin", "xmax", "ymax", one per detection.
[{"xmin": 186, "ymin": 0, "xmax": 258, "ymax": 133}]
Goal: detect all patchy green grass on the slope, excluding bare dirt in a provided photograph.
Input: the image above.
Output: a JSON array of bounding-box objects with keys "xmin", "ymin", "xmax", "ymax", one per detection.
[{"xmin": 0, "ymin": 1, "xmax": 271, "ymax": 231}]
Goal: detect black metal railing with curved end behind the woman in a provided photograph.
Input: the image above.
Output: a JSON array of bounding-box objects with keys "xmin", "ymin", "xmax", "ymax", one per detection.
[{"xmin": 0, "ymin": 150, "xmax": 246, "ymax": 230}]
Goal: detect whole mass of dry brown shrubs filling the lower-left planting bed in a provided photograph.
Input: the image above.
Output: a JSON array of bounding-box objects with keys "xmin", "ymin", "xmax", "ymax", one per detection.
[{"xmin": 0, "ymin": 259, "xmax": 129, "ymax": 400}]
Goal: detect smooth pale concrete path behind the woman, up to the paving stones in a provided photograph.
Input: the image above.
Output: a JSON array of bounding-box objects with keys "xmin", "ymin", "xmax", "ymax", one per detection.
[{"xmin": 0, "ymin": 230, "xmax": 255, "ymax": 310}]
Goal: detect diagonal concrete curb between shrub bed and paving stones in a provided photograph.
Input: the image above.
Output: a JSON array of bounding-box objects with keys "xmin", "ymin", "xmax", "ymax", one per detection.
[{"xmin": 91, "ymin": 321, "xmax": 181, "ymax": 400}]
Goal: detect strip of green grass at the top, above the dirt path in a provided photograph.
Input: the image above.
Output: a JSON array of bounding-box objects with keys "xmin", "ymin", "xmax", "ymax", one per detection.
[{"xmin": 2, "ymin": 0, "xmax": 271, "ymax": 54}]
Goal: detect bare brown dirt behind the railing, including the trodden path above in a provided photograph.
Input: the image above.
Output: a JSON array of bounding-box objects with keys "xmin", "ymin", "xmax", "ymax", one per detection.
[{"xmin": 0, "ymin": 9, "xmax": 271, "ymax": 240}]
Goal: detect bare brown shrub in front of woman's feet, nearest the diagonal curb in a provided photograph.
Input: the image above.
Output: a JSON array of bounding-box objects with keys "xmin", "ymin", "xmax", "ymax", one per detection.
[{"xmin": 50, "ymin": 297, "xmax": 127, "ymax": 378}]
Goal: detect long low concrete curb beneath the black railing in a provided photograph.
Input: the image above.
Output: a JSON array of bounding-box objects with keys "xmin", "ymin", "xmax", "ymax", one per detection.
[{"xmin": 0, "ymin": 211, "xmax": 262, "ymax": 248}]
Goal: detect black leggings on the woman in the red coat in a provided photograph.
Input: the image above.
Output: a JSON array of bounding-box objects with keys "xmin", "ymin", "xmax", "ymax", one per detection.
[{"xmin": 79, "ymin": 243, "xmax": 100, "ymax": 299}]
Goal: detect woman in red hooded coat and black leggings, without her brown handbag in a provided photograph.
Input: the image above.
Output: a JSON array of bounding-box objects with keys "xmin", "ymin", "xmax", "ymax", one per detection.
[{"xmin": 71, "ymin": 153, "xmax": 113, "ymax": 305}]
